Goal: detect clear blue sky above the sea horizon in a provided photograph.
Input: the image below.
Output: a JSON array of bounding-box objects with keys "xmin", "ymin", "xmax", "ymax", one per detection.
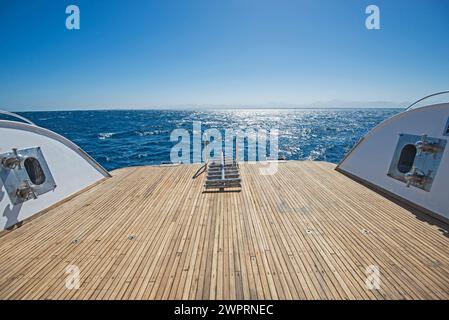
[{"xmin": 0, "ymin": 0, "xmax": 449, "ymax": 110}]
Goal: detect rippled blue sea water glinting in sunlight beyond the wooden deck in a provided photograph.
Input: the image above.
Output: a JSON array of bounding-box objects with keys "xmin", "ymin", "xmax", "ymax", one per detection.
[{"xmin": 14, "ymin": 109, "xmax": 401, "ymax": 170}]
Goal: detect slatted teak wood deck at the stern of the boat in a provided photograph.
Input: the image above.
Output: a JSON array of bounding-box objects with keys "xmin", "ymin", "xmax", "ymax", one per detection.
[{"xmin": 0, "ymin": 161, "xmax": 449, "ymax": 299}]
